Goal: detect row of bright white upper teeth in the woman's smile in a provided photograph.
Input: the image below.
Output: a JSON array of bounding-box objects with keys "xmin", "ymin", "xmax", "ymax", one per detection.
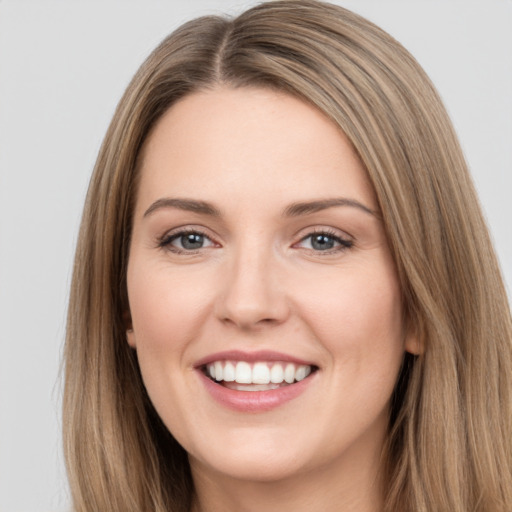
[{"xmin": 206, "ymin": 361, "xmax": 311, "ymax": 384}]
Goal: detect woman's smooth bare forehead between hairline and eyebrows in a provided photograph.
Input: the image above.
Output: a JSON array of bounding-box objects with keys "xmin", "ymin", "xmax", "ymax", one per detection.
[{"xmin": 138, "ymin": 87, "xmax": 376, "ymax": 215}]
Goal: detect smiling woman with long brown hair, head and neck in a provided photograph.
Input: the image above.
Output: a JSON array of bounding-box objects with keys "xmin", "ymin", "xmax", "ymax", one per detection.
[{"xmin": 64, "ymin": 0, "xmax": 512, "ymax": 512}]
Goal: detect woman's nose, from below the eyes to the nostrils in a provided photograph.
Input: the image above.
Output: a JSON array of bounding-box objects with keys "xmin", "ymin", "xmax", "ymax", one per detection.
[{"xmin": 216, "ymin": 245, "xmax": 289, "ymax": 330}]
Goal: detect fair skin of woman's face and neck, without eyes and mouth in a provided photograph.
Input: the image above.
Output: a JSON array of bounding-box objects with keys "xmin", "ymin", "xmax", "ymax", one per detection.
[{"xmin": 127, "ymin": 87, "xmax": 416, "ymax": 512}]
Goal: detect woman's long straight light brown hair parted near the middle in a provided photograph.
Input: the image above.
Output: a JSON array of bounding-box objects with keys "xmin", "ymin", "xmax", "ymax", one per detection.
[{"xmin": 64, "ymin": 0, "xmax": 512, "ymax": 512}]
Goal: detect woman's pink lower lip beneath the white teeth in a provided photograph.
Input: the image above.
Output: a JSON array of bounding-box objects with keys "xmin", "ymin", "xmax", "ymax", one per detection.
[{"xmin": 198, "ymin": 370, "xmax": 316, "ymax": 413}]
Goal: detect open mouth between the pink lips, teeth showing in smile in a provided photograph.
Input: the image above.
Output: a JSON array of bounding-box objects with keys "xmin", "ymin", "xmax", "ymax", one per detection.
[{"xmin": 202, "ymin": 361, "xmax": 318, "ymax": 391}]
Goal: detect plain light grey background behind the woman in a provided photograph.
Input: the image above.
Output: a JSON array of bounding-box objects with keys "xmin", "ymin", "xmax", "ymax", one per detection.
[{"xmin": 0, "ymin": 0, "xmax": 512, "ymax": 512}]
